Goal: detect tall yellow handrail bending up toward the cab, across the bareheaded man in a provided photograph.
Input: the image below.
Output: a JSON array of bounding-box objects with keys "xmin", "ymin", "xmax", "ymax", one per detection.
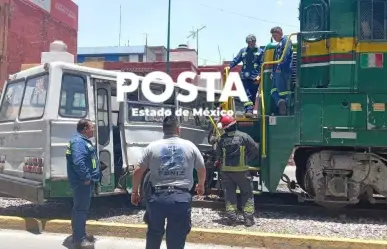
[{"xmin": 259, "ymin": 33, "xmax": 298, "ymax": 158}]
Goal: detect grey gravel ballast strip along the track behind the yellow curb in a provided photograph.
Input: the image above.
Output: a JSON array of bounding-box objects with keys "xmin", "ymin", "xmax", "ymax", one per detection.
[{"xmin": 0, "ymin": 195, "xmax": 387, "ymax": 239}]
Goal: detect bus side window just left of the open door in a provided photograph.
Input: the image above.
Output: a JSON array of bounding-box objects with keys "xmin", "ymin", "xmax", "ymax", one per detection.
[{"xmin": 59, "ymin": 74, "xmax": 87, "ymax": 118}]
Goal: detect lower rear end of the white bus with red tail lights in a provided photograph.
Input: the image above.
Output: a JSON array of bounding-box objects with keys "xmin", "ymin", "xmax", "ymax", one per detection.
[{"xmin": 0, "ymin": 121, "xmax": 48, "ymax": 202}]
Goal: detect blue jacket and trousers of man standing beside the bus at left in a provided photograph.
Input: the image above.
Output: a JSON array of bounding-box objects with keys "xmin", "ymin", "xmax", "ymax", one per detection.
[{"xmin": 66, "ymin": 133, "xmax": 100, "ymax": 242}]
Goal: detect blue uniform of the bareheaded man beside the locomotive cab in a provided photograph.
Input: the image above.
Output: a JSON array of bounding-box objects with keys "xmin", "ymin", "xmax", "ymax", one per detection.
[{"xmin": 271, "ymin": 36, "xmax": 293, "ymax": 109}]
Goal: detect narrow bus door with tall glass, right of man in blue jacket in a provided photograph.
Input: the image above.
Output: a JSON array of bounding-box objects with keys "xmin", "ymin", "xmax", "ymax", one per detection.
[{"xmin": 93, "ymin": 78, "xmax": 114, "ymax": 192}]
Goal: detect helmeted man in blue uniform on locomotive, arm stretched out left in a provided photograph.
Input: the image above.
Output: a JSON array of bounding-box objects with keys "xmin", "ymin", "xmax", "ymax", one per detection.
[{"xmin": 227, "ymin": 35, "xmax": 263, "ymax": 117}]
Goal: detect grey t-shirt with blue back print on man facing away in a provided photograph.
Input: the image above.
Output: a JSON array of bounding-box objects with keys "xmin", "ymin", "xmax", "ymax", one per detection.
[{"xmin": 138, "ymin": 137, "xmax": 205, "ymax": 190}]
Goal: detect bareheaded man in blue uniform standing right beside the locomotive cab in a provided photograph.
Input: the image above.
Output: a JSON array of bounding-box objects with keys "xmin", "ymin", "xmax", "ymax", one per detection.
[{"xmin": 270, "ymin": 27, "xmax": 293, "ymax": 115}]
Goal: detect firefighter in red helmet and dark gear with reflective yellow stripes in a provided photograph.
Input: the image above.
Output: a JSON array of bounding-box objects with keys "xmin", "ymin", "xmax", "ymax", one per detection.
[{"xmin": 216, "ymin": 116, "xmax": 259, "ymax": 226}]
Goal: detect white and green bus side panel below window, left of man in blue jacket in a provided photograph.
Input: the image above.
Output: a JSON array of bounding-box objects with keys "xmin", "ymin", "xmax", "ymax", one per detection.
[{"xmin": 47, "ymin": 120, "xmax": 77, "ymax": 197}]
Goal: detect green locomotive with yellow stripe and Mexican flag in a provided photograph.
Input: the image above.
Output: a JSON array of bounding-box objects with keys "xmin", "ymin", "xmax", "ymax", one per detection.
[{"xmin": 226, "ymin": 0, "xmax": 387, "ymax": 208}]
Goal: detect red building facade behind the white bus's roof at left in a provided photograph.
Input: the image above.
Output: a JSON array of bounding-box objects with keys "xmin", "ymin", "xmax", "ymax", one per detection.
[{"xmin": 0, "ymin": 0, "xmax": 78, "ymax": 90}]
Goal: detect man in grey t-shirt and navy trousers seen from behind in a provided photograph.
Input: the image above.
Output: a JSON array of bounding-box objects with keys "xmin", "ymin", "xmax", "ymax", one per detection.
[{"xmin": 131, "ymin": 116, "xmax": 206, "ymax": 249}]
